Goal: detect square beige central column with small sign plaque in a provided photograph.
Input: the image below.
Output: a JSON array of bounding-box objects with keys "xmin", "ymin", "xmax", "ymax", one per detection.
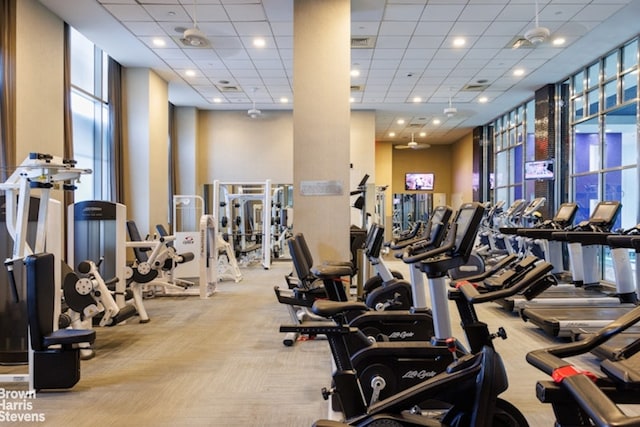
[{"xmin": 293, "ymin": 0, "xmax": 351, "ymax": 261}]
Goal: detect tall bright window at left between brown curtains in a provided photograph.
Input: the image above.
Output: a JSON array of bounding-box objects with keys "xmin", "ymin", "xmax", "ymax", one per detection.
[{"xmin": 70, "ymin": 29, "xmax": 110, "ymax": 200}]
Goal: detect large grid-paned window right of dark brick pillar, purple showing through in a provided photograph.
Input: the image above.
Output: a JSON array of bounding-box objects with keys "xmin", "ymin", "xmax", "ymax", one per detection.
[{"xmin": 564, "ymin": 39, "xmax": 640, "ymax": 281}]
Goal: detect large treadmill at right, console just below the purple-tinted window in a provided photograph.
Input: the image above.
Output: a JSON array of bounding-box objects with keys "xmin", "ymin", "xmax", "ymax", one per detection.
[{"xmin": 520, "ymin": 201, "xmax": 637, "ymax": 338}]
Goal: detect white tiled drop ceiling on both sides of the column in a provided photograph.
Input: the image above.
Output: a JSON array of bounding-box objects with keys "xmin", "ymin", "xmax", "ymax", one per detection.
[{"xmin": 39, "ymin": 0, "xmax": 640, "ymax": 143}]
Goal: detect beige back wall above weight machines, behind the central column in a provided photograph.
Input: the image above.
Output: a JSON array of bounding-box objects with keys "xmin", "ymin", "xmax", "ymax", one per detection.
[{"xmin": 195, "ymin": 108, "xmax": 375, "ymax": 189}]
